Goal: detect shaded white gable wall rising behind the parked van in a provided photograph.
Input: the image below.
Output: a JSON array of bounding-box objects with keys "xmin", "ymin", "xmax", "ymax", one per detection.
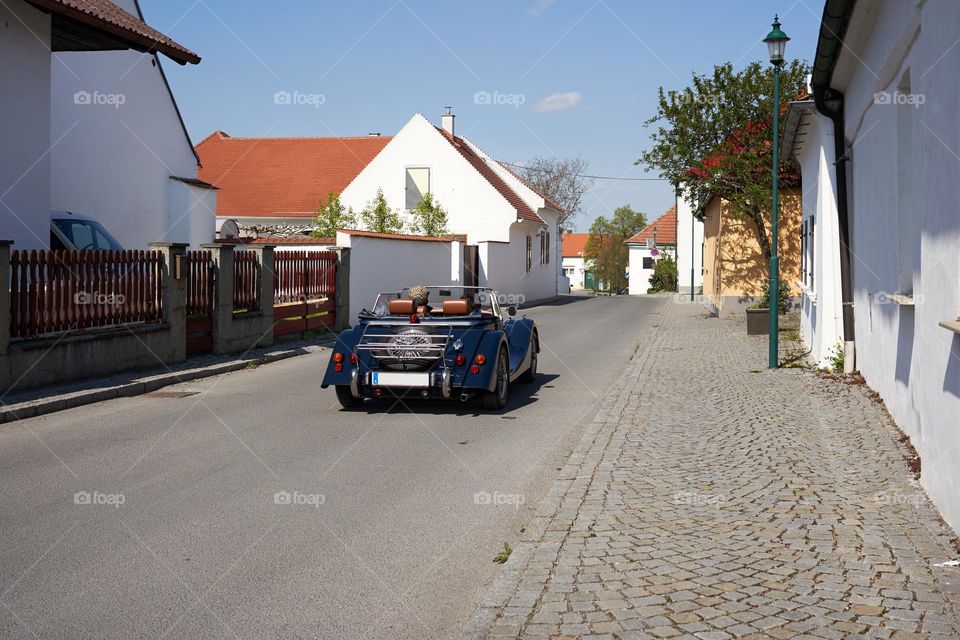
[{"xmin": 48, "ymin": 0, "xmax": 214, "ymax": 248}]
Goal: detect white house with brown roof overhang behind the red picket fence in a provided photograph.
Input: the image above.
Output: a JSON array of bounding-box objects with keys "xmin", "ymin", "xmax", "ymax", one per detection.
[{"xmin": 0, "ymin": 0, "xmax": 216, "ymax": 249}]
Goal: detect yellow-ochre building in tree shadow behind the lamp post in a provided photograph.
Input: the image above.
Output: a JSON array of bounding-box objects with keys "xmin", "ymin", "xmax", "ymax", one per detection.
[{"xmin": 699, "ymin": 188, "xmax": 802, "ymax": 318}]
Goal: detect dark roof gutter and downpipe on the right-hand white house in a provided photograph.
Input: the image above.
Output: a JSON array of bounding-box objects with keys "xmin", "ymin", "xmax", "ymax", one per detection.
[{"xmin": 811, "ymin": 0, "xmax": 856, "ymax": 373}]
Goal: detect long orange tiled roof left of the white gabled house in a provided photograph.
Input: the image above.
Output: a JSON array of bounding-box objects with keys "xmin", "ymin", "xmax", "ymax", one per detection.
[{"xmin": 197, "ymin": 131, "xmax": 393, "ymax": 218}]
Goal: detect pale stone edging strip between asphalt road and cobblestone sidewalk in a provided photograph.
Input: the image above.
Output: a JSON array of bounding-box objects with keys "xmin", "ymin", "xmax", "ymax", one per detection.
[{"xmin": 459, "ymin": 303, "xmax": 673, "ymax": 640}]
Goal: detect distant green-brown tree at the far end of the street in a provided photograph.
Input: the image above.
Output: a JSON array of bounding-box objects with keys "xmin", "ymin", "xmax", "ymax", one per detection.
[{"xmin": 583, "ymin": 205, "xmax": 647, "ymax": 291}]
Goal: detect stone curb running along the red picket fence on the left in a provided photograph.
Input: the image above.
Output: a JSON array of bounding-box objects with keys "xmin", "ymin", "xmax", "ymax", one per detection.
[{"xmin": 0, "ymin": 344, "xmax": 329, "ymax": 423}]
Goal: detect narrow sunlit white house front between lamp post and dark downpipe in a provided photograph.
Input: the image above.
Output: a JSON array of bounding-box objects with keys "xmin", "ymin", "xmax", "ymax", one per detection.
[{"xmin": 781, "ymin": 99, "xmax": 852, "ymax": 367}]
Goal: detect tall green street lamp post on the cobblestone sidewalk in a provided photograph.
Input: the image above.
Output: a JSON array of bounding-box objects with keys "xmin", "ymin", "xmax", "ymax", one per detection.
[{"xmin": 763, "ymin": 16, "xmax": 790, "ymax": 369}]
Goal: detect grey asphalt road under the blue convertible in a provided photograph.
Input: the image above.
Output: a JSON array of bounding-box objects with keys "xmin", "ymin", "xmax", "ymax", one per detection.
[{"xmin": 0, "ymin": 297, "xmax": 664, "ymax": 640}]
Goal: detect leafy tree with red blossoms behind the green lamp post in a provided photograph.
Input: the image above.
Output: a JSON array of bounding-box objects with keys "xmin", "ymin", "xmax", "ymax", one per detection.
[{"xmin": 636, "ymin": 60, "xmax": 809, "ymax": 266}]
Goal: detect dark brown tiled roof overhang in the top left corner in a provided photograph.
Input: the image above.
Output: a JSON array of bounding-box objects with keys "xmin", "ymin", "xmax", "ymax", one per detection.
[{"xmin": 27, "ymin": 0, "xmax": 200, "ymax": 64}]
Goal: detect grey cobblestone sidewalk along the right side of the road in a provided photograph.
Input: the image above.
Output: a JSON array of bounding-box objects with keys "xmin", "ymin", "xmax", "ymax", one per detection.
[{"xmin": 463, "ymin": 304, "xmax": 960, "ymax": 640}]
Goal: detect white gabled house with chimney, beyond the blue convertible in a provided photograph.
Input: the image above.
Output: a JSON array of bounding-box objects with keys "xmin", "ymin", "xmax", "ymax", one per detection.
[{"xmin": 340, "ymin": 110, "xmax": 566, "ymax": 302}]
